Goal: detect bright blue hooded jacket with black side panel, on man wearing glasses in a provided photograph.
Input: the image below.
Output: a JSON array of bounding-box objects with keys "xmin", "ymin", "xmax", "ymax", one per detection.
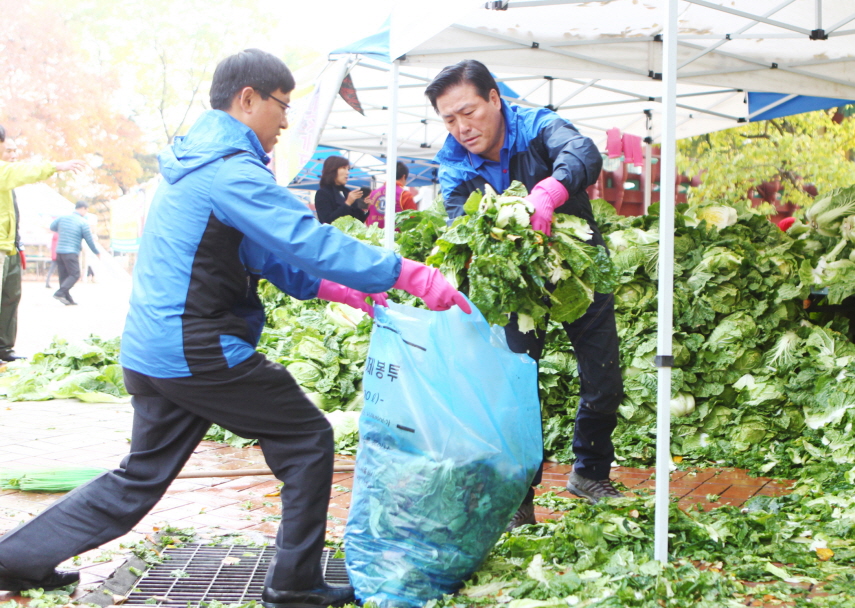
[{"xmin": 121, "ymin": 110, "xmax": 401, "ymax": 378}]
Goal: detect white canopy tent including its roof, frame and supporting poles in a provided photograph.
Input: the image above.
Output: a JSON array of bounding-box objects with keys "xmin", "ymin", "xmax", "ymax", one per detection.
[{"xmin": 321, "ymin": 0, "xmax": 855, "ymax": 561}]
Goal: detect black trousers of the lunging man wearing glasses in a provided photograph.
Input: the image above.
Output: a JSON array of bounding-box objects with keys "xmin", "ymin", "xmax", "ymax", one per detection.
[{"xmin": 0, "ymin": 353, "xmax": 334, "ymax": 590}]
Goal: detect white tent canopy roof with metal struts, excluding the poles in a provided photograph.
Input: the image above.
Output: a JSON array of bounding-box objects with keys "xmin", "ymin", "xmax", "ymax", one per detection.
[{"xmin": 321, "ymin": 0, "xmax": 855, "ymax": 151}]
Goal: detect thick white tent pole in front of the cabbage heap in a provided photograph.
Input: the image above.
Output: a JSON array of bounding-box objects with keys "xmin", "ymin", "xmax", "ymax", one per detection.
[{"xmin": 653, "ymin": 0, "xmax": 677, "ymax": 564}]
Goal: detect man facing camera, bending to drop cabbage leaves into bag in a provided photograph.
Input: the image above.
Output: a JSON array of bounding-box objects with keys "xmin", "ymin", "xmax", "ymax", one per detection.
[{"xmin": 425, "ymin": 60, "xmax": 623, "ymax": 528}]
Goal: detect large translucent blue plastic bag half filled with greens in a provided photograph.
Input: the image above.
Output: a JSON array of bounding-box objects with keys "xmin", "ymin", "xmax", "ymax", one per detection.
[{"xmin": 345, "ymin": 304, "xmax": 543, "ymax": 607}]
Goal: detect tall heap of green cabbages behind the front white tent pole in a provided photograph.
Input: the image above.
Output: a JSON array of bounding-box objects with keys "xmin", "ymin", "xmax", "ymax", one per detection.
[{"xmin": 542, "ymin": 195, "xmax": 855, "ymax": 477}]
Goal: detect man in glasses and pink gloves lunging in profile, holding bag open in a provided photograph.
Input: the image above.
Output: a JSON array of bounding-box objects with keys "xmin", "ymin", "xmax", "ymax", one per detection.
[{"xmin": 0, "ymin": 49, "xmax": 469, "ymax": 608}]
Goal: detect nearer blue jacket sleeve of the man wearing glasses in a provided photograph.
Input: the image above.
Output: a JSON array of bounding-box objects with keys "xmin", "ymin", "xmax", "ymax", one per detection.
[{"xmin": 210, "ymin": 154, "xmax": 401, "ymax": 293}]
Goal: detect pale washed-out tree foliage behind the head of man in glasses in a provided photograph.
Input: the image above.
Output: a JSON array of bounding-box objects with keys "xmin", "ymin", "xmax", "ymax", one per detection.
[{"xmin": 58, "ymin": 0, "xmax": 313, "ymax": 147}]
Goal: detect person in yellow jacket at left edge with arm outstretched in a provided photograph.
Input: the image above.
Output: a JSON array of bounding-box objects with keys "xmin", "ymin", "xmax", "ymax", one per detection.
[{"xmin": 0, "ymin": 125, "xmax": 86, "ymax": 361}]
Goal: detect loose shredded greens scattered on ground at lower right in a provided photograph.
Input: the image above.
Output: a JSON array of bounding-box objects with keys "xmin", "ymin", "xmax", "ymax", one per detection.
[{"xmin": 406, "ymin": 466, "xmax": 855, "ymax": 608}]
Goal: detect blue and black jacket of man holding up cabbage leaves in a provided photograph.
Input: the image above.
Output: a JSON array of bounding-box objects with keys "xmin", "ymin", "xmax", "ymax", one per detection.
[{"xmin": 435, "ymin": 100, "xmax": 604, "ymax": 245}]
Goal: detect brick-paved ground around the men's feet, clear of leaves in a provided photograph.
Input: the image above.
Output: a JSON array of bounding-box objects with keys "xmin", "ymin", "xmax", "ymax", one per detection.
[{"xmin": 0, "ymin": 400, "xmax": 786, "ymax": 601}]
